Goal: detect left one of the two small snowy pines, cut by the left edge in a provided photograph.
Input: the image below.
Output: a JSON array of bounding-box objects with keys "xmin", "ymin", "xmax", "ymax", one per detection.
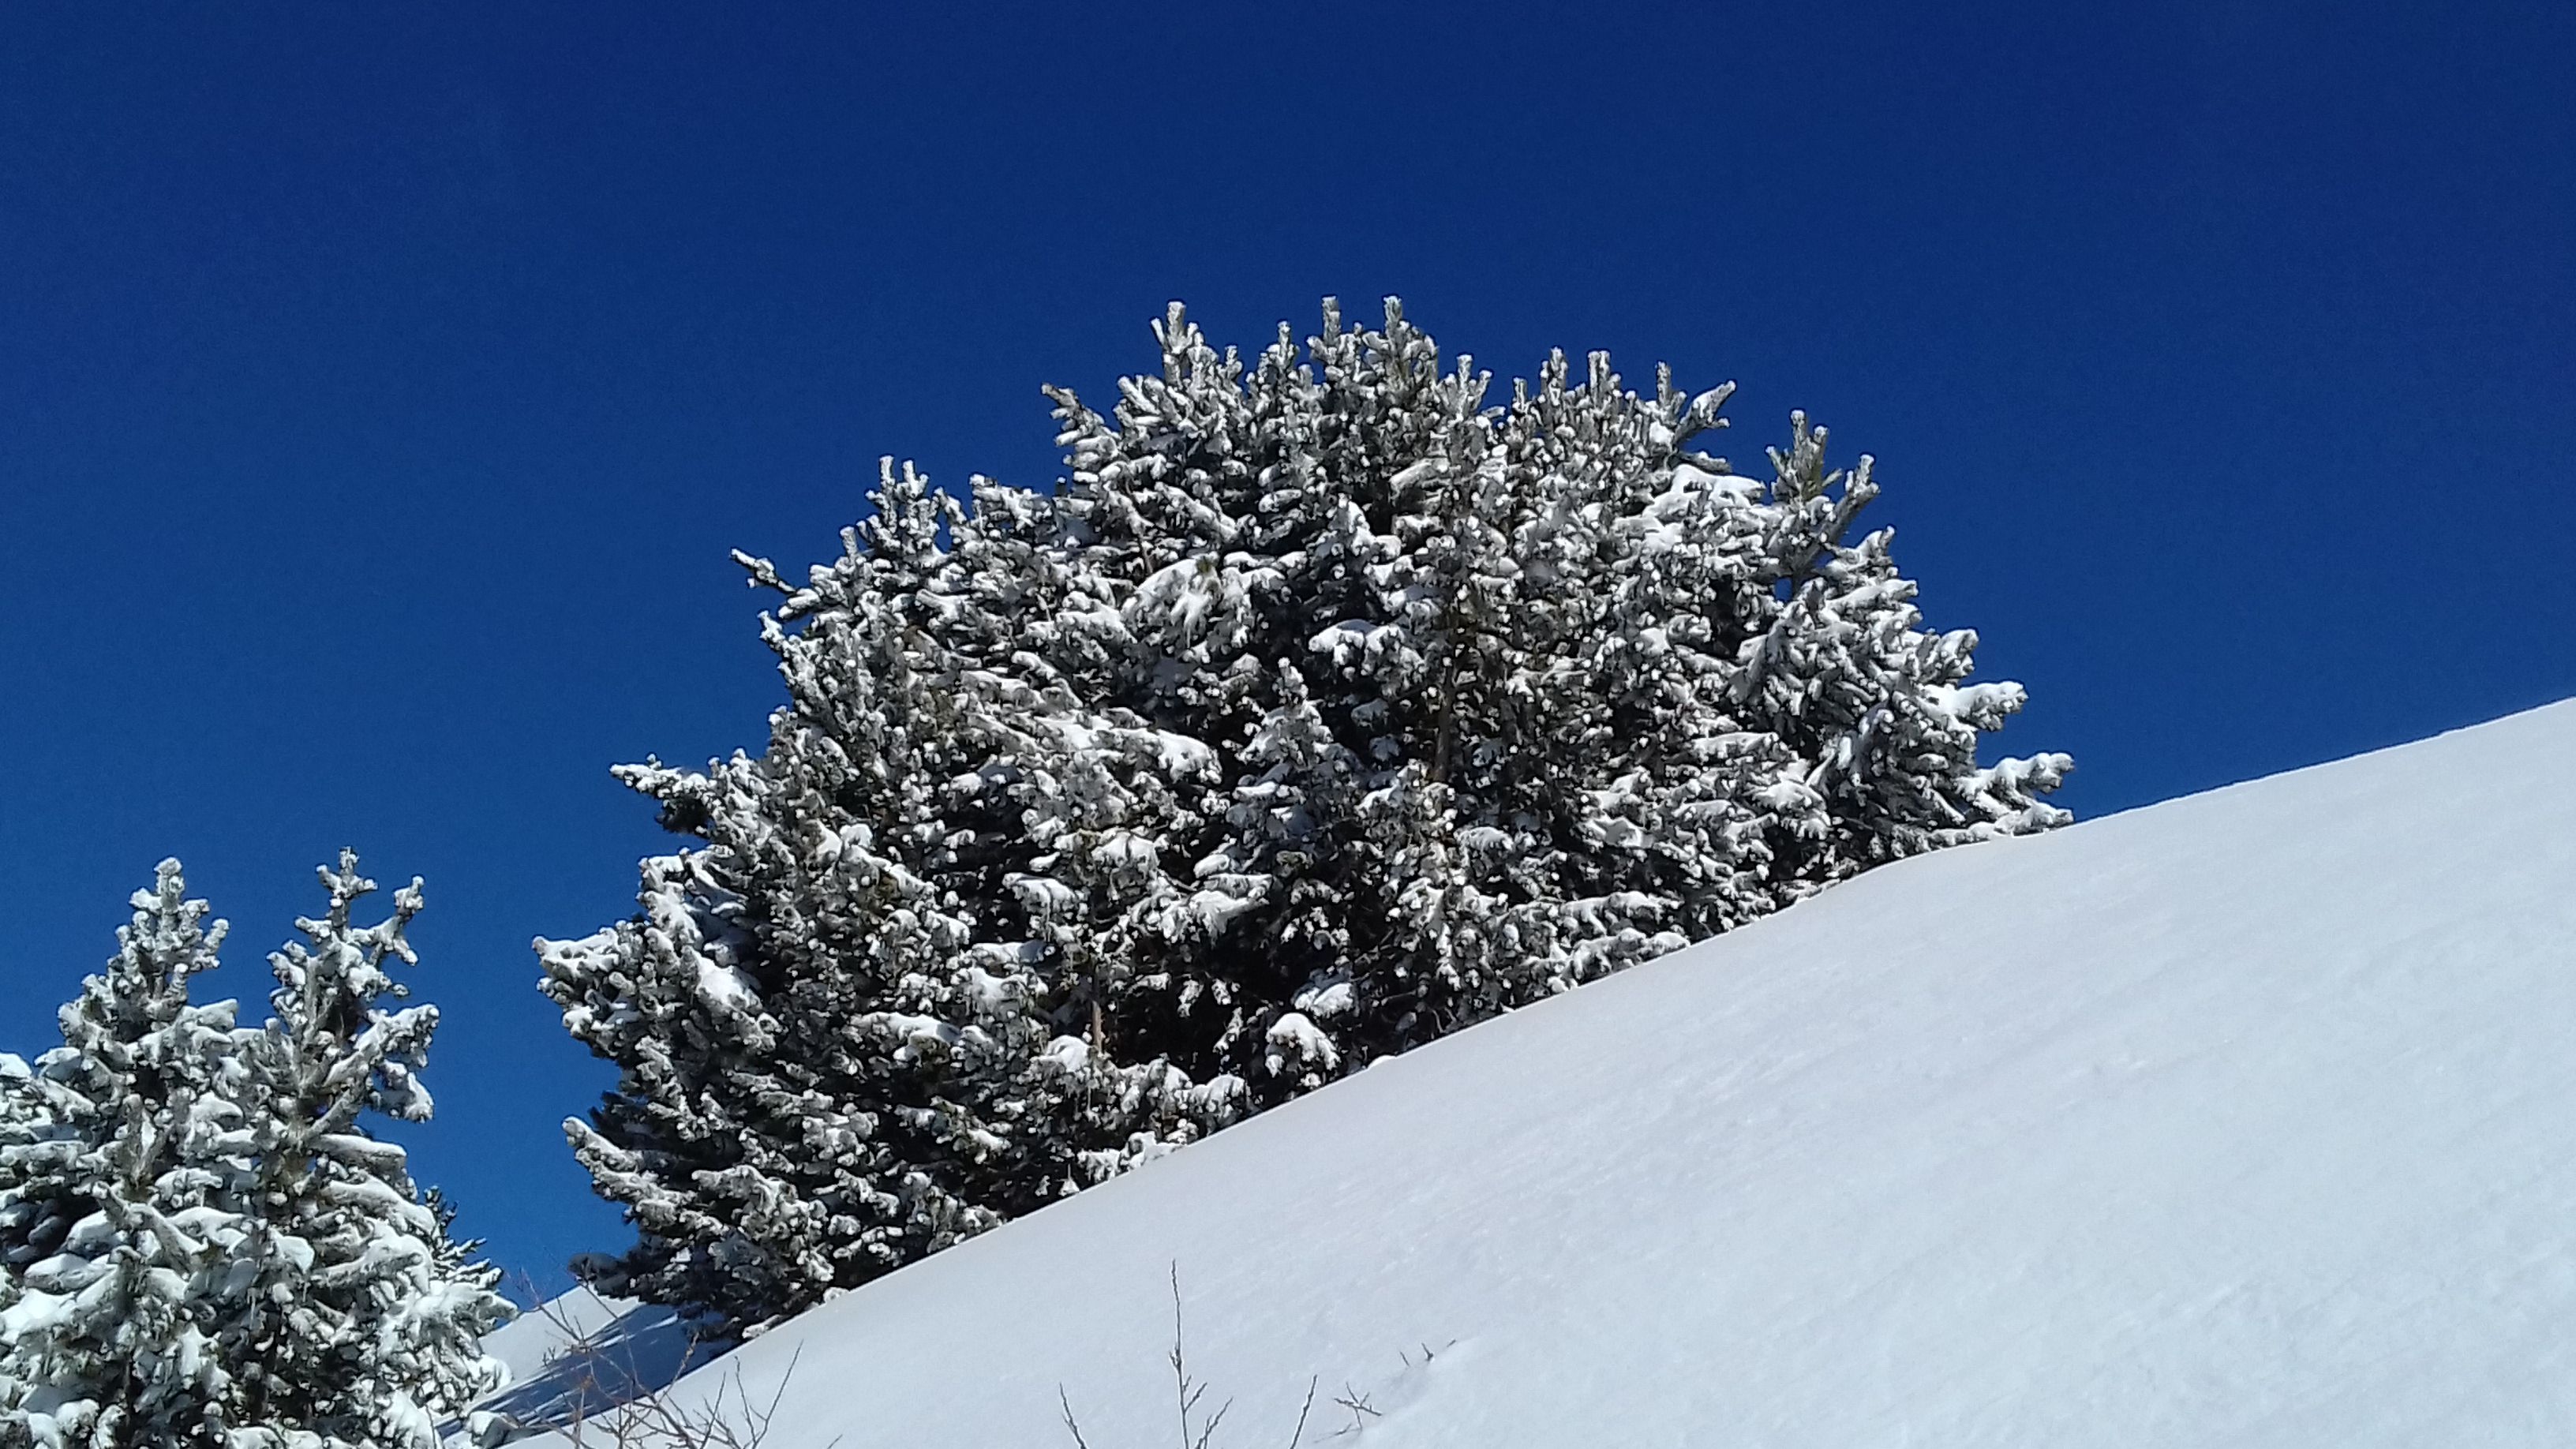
[{"xmin": 0, "ymin": 861, "xmax": 237, "ymax": 1449}]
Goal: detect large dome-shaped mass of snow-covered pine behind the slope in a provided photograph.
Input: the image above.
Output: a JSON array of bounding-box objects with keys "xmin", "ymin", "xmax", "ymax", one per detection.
[{"xmin": 541, "ymin": 301, "xmax": 2069, "ymax": 1323}]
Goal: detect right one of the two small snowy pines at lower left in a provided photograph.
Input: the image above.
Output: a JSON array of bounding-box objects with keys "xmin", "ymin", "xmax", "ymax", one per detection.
[{"xmin": 214, "ymin": 851, "xmax": 513, "ymax": 1449}]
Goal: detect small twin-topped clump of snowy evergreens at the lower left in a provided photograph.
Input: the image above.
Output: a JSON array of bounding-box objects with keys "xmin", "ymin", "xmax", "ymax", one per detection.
[{"xmin": 0, "ymin": 856, "xmax": 510, "ymax": 1449}]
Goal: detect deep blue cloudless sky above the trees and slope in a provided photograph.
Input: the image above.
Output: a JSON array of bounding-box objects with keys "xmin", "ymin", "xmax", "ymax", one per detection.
[{"xmin": 0, "ymin": 6, "xmax": 2576, "ymax": 1279}]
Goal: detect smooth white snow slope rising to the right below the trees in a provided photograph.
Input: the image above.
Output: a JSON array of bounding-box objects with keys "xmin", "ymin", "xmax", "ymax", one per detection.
[{"xmin": 479, "ymin": 702, "xmax": 2576, "ymax": 1449}]
